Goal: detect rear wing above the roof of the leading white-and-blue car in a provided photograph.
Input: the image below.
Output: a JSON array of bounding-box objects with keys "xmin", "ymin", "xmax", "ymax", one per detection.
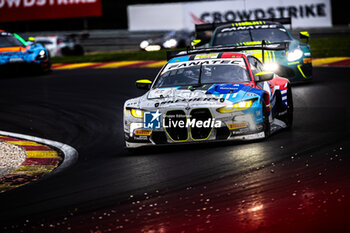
[{"xmin": 167, "ymin": 40, "xmax": 288, "ymax": 63}]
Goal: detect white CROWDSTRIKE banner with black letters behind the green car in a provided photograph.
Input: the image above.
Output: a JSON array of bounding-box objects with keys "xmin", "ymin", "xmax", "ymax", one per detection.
[{"xmin": 128, "ymin": 0, "xmax": 332, "ymax": 31}]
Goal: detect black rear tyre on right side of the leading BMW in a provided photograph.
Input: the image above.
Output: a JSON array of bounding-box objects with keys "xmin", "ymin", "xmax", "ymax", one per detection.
[{"xmin": 276, "ymin": 85, "xmax": 294, "ymax": 129}]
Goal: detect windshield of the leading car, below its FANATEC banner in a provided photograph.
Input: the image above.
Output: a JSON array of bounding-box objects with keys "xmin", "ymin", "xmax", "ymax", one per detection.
[{"xmin": 154, "ymin": 65, "xmax": 250, "ymax": 88}]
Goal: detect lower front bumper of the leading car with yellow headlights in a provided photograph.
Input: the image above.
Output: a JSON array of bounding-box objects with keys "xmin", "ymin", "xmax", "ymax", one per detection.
[{"xmin": 124, "ymin": 108, "xmax": 265, "ymax": 148}]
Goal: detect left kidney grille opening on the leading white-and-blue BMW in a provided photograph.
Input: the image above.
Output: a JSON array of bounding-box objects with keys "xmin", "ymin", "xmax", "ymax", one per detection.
[{"xmin": 165, "ymin": 110, "xmax": 188, "ymax": 141}]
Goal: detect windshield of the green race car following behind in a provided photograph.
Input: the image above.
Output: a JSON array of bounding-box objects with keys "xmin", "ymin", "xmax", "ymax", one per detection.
[{"xmin": 213, "ymin": 28, "xmax": 291, "ymax": 46}]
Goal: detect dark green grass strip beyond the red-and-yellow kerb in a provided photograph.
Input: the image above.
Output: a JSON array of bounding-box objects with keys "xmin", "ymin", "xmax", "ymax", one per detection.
[{"xmin": 52, "ymin": 36, "xmax": 350, "ymax": 64}]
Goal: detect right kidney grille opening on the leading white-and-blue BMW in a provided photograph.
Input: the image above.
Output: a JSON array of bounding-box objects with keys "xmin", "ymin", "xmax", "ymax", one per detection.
[{"xmin": 190, "ymin": 108, "xmax": 212, "ymax": 140}]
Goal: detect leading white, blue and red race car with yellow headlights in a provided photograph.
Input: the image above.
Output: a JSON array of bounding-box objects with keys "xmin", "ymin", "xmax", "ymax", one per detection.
[{"xmin": 123, "ymin": 44, "xmax": 293, "ymax": 148}]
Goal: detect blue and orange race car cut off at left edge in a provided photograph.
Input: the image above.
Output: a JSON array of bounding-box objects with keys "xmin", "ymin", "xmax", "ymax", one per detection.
[{"xmin": 0, "ymin": 30, "xmax": 51, "ymax": 73}]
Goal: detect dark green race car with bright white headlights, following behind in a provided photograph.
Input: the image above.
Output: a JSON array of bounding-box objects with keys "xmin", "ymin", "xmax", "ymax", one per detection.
[{"xmin": 196, "ymin": 18, "xmax": 312, "ymax": 82}]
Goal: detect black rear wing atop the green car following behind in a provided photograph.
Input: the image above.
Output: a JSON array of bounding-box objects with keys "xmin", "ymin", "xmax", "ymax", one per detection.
[{"xmin": 195, "ymin": 17, "xmax": 292, "ymax": 45}]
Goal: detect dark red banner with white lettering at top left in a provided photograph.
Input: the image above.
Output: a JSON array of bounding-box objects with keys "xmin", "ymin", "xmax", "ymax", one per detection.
[{"xmin": 0, "ymin": 0, "xmax": 102, "ymax": 22}]
